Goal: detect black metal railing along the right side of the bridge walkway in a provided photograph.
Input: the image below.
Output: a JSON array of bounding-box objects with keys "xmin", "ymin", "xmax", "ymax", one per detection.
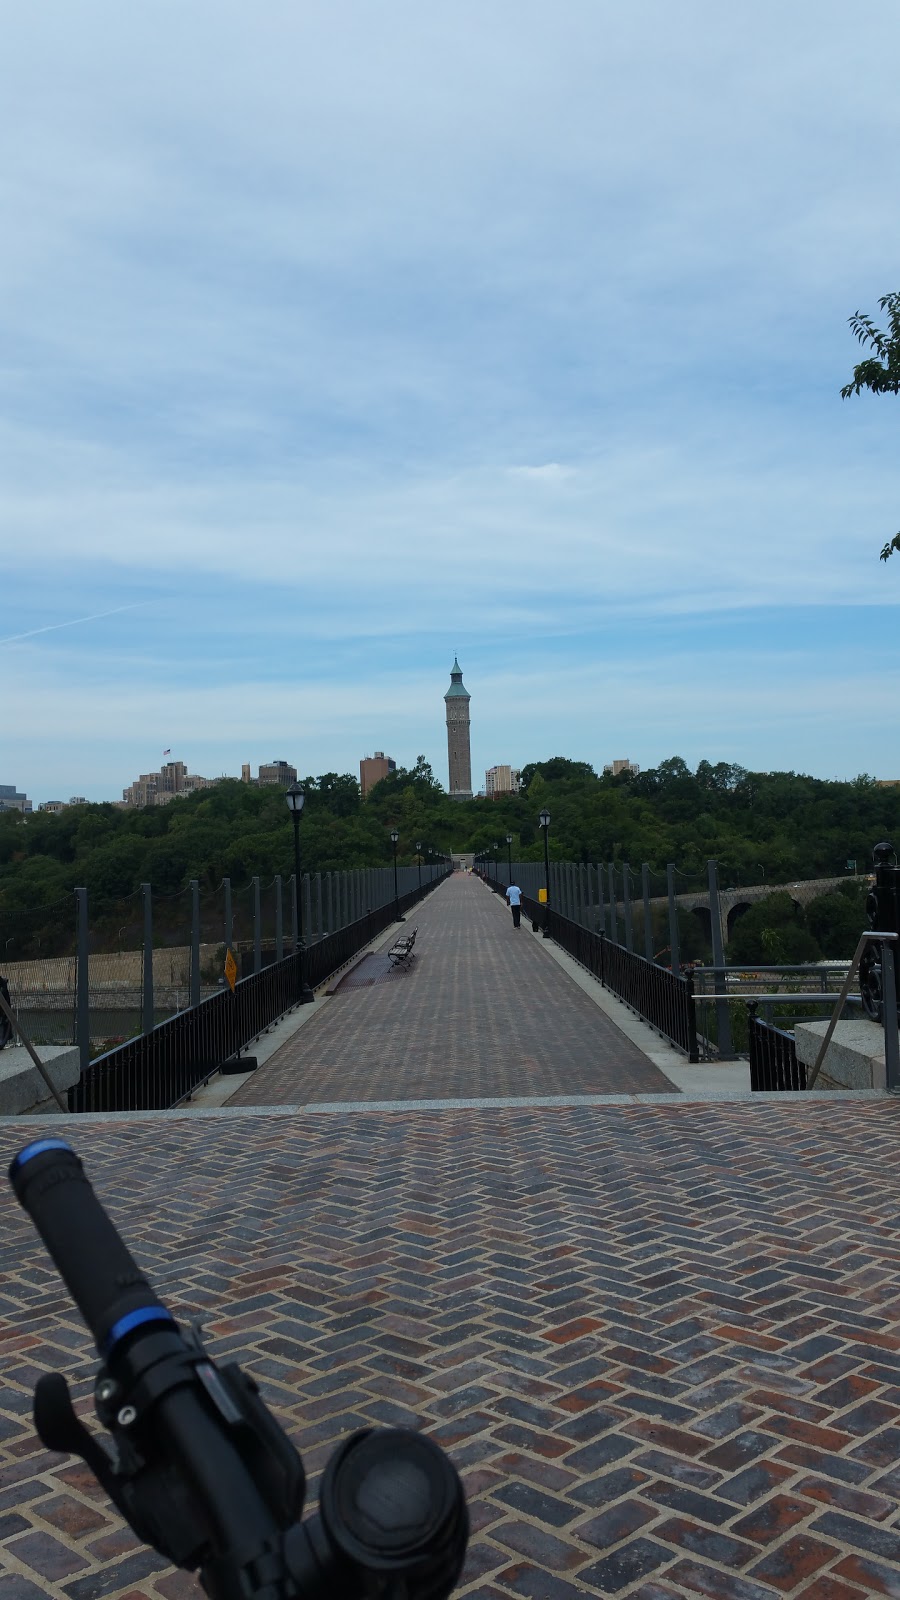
[{"xmin": 485, "ymin": 878, "xmax": 700, "ymax": 1061}]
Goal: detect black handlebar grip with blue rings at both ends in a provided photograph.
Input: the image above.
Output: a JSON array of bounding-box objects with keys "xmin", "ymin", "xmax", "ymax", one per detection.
[{"xmin": 10, "ymin": 1139, "xmax": 175, "ymax": 1360}]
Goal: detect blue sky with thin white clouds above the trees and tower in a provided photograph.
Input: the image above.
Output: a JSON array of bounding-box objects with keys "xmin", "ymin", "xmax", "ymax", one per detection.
[{"xmin": 0, "ymin": 0, "xmax": 900, "ymax": 803}]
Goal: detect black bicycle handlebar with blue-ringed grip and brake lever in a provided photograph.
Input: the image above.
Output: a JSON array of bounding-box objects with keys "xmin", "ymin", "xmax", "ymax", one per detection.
[{"xmin": 10, "ymin": 1139, "xmax": 468, "ymax": 1600}]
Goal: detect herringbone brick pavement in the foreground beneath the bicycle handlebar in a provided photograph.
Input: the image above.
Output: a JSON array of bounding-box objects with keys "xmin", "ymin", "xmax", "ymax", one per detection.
[{"xmin": 0, "ymin": 1096, "xmax": 900, "ymax": 1600}]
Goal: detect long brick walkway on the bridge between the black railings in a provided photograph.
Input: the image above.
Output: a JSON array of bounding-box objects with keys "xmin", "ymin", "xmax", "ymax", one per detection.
[{"xmin": 231, "ymin": 875, "xmax": 676, "ymax": 1106}]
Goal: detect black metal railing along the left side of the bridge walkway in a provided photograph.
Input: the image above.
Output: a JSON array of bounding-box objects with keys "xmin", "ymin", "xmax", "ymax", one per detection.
[{"xmin": 69, "ymin": 872, "xmax": 447, "ymax": 1112}]
